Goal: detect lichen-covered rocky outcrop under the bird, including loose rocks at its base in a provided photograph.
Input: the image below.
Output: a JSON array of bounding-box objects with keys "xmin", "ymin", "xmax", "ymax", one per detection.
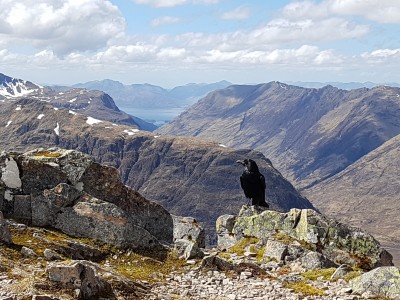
[{"xmin": 217, "ymin": 206, "xmax": 392, "ymax": 270}]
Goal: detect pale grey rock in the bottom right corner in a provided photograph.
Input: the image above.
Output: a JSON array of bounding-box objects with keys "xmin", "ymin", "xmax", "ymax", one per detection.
[{"xmin": 350, "ymin": 267, "xmax": 400, "ymax": 298}]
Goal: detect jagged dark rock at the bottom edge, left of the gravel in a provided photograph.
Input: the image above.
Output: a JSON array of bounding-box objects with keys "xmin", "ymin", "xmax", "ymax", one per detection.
[{"xmin": 46, "ymin": 261, "xmax": 113, "ymax": 299}]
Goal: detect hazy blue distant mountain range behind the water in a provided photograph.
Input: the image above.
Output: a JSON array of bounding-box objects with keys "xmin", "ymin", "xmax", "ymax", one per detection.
[{"xmin": 74, "ymin": 79, "xmax": 231, "ymax": 109}]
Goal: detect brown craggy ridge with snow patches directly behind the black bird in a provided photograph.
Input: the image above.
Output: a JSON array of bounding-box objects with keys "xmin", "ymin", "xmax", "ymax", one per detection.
[{"xmin": 0, "ymin": 98, "xmax": 313, "ymax": 242}]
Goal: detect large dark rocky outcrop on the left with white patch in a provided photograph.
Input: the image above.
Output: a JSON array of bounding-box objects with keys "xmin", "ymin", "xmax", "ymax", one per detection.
[{"xmin": 0, "ymin": 148, "xmax": 173, "ymax": 248}]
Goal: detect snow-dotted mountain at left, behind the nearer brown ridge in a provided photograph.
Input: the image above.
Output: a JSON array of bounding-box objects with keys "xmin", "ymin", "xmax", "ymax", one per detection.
[{"xmin": 0, "ymin": 74, "xmax": 157, "ymax": 131}]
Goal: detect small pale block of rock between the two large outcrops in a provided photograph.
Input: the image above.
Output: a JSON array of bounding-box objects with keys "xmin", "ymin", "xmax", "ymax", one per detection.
[{"xmin": 172, "ymin": 215, "xmax": 206, "ymax": 248}]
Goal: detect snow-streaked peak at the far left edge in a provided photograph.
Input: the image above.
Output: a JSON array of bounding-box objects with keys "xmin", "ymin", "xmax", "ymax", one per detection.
[{"xmin": 0, "ymin": 73, "xmax": 42, "ymax": 98}]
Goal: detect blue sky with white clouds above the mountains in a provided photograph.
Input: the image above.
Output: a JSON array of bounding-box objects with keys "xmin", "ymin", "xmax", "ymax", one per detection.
[{"xmin": 0, "ymin": 0, "xmax": 400, "ymax": 88}]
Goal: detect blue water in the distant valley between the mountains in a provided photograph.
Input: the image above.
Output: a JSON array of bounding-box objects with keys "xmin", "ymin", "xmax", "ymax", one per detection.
[{"xmin": 119, "ymin": 107, "xmax": 185, "ymax": 126}]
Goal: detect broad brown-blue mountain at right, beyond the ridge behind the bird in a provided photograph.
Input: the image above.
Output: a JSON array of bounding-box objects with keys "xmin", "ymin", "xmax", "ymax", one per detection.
[{"xmin": 157, "ymin": 82, "xmax": 400, "ymax": 188}]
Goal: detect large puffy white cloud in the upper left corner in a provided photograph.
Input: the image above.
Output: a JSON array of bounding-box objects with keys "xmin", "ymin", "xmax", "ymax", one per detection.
[{"xmin": 0, "ymin": 0, "xmax": 125, "ymax": 55}]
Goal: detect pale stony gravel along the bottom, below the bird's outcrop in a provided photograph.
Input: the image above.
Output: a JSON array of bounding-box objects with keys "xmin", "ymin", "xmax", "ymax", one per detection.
[{"xmin": 149, "ymin": 268, "xmax": 362, "ymax": 300}]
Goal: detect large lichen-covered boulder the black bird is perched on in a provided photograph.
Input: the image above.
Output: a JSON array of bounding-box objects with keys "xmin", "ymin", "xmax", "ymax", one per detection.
[{"xmin": 222, "ymin": 206, "xmax": 393, "ymax": 270}]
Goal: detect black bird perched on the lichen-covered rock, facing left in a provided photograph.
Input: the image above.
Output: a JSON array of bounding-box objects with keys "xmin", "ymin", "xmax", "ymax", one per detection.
[{"xmin": 236, "ymin": 159, "xmax": 269, "ymax": 207}]
